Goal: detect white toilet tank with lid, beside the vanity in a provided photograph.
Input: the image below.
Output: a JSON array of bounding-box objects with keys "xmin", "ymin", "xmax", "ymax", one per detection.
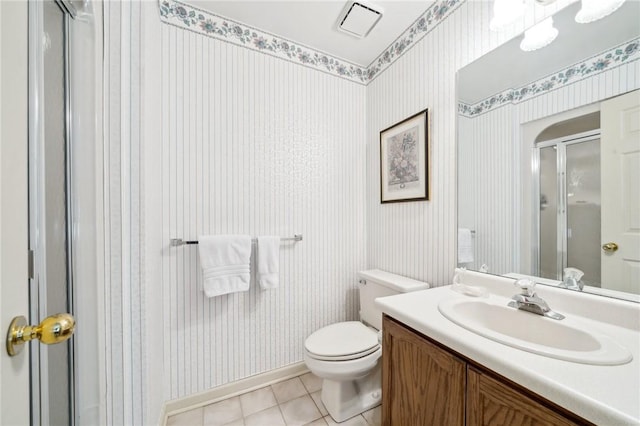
[{"xmin": 358, "ymin": 269, "xmax": 429, "ymax": 330}]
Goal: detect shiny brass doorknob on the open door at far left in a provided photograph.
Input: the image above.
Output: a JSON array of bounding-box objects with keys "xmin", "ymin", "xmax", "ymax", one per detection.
[{"xmin": 7, "ymin": 314, "xmax": 76, "ymax": 356}]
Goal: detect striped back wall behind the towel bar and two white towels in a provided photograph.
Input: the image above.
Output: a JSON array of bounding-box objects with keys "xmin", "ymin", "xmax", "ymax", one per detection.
[{"xmin": 154, "ymin": 13, "xmax": 366, "ymax": 399}]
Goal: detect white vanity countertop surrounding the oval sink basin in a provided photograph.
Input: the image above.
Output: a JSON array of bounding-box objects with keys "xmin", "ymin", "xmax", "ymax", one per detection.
[{"xmin": 376, "ymin": 272, "xmax": 640, "ymax": 426}]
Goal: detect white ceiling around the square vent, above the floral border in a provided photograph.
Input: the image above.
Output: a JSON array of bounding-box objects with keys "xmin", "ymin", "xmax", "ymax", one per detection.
[{"xmin": 185, "ymin": 0, "xmax": 434, "ymax": 67}]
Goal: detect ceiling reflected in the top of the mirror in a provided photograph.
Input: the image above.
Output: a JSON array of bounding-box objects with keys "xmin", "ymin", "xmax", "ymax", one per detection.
[{"xmin": 458, "ymin": 1, "xmax": 640, "ymax": 105}]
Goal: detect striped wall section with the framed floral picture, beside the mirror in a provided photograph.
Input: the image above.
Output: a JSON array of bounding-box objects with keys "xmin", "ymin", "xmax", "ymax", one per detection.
[{"xmin": 367, "ymin": 0, "xmax": 572, "ymax": 286}]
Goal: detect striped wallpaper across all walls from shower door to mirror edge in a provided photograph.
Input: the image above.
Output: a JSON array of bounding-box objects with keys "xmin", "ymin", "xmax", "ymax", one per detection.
[{"xmin": 103, "ymin": 0, "xmax": 636, "ymax": 424}]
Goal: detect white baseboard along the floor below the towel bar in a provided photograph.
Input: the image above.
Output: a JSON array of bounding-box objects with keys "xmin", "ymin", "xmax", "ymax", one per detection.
[{"xmin": 160, "ymin": 362, "xmax": 309, "ymax": 426}]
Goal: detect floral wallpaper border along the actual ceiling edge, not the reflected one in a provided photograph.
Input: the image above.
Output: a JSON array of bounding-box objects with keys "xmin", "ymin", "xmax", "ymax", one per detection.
[{"xmin": 158, "ymin": 0, "xmax": 466, "ymax": 85}]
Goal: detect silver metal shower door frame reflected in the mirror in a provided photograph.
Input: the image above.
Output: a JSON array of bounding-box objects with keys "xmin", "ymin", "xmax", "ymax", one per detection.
[{"xmin": 531, "ymin": 129, "xmax": 600, "ymax": 281}]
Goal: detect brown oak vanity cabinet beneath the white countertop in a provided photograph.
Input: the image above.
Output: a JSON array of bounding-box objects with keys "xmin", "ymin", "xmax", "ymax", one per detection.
[{"xmin": 382, "ymin": 315, "xmax": 591, "ymax": 426}]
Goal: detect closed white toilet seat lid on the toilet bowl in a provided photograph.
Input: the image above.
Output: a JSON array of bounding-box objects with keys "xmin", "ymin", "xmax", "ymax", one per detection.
[{"xmin": 304, "ymin": 321, "xmax": 380, "ymax": 361}]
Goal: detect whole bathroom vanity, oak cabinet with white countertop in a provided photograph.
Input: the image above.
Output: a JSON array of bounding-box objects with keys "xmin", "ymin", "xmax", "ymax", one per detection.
[{"xmin": 376, "ymin": 272, "xmax": 640, "ymax": 425}]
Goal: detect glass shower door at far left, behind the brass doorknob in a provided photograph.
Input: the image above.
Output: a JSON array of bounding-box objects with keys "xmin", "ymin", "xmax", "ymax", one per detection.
[{"xmin": 29, "ymin": 1, "xmax": 75, "ymax": 425}]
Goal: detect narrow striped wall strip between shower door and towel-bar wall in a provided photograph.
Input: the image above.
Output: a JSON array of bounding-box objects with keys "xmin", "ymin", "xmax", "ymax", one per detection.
[{"xmin": 102, "ymin": 2, "xmax": 145, "ymax": 425}]
